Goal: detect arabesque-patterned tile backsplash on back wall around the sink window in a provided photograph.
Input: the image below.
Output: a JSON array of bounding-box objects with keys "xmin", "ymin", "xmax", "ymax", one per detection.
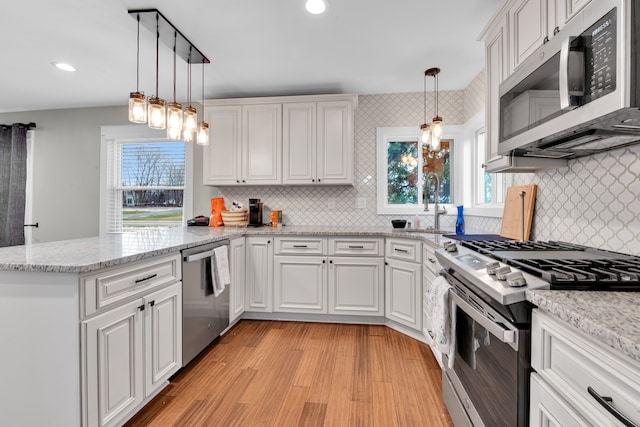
[{"xmin": 219, "ymin": 73, "xmax": 500, "ymax": 232}]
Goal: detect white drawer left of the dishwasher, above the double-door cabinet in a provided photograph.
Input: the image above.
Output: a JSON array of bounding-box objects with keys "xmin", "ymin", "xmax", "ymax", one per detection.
[{"xmin": 80, "ymin": 253, "xmax": 182, "ymax": 317}]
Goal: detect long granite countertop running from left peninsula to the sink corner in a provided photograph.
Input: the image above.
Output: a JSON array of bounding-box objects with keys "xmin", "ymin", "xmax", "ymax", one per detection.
[{"xmin": 0, "ymin": 227, "xmax": 448, "ymax": 273}]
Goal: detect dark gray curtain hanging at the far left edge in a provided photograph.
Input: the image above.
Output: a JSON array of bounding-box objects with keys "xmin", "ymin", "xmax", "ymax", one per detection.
[{"xmin": 0, "ymin": 123, "xmax": 32, "ymax": 247}]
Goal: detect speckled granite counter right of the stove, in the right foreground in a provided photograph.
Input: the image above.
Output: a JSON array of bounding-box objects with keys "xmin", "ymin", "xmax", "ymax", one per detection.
[{"xmin": 527, "ymin": 290, "xmax": 640, "ymax": 361}]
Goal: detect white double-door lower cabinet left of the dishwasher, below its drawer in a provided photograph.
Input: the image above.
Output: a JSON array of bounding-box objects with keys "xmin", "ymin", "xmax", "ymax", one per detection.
[{"xmin": 82, "ymin": 282, "xmax": 182, "ymax": 426}]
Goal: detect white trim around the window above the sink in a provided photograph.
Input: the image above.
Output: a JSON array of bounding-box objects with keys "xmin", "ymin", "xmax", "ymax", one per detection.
[{"xmin": 376, "ymin": 125, "xmax": 464, "ymax": 216}]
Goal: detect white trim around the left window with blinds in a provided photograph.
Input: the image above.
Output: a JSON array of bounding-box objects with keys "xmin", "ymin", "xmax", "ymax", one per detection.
[{"xmin": 100, "ymin": 125, "xmax": 193, "ymax": 236}]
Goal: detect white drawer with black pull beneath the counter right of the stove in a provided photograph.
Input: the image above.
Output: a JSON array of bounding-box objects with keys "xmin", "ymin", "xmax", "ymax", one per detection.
[{"xmin": 531, "ymin": 310, "xmax": 640, "ymax": 424}]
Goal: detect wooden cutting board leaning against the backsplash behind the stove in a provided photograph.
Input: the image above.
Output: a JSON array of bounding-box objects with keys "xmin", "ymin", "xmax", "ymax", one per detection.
[{"xmin": 500, "ymin": 184, "xmax": 536, "ymax": 240}]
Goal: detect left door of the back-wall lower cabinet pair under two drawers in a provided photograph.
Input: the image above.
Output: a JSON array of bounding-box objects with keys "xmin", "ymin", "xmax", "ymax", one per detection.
[{"xmin": 273, "ymin": 256, "xmax": 327, "ymax": 313}]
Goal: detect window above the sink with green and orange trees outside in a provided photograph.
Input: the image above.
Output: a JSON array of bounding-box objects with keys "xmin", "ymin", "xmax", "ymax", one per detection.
[{"xmin": 376, "ymin": 127, "xmax": 454, "ymax": 214}]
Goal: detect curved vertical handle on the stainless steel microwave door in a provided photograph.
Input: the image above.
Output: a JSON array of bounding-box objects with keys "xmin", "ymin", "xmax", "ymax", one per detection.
[{"xmin": 559, "ymin": 37, "xmax": 584, "ymax": 111}]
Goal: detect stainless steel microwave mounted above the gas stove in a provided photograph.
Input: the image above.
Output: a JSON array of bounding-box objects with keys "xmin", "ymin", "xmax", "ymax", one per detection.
[{"xmin": 498, "ymin": 0, "xmax": 640, "ymax": 158}]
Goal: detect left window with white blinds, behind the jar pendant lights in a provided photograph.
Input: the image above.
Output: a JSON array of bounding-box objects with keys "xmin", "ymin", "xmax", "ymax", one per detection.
[{"xmin": 101, "ymin": 125, "xmax": 190, "ymax": 234}]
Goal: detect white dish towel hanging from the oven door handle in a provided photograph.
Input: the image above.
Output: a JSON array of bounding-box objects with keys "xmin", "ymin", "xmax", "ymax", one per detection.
[{"xmin": 427, "ymin": 276, "xmax": 453, "ymax": 360}]
